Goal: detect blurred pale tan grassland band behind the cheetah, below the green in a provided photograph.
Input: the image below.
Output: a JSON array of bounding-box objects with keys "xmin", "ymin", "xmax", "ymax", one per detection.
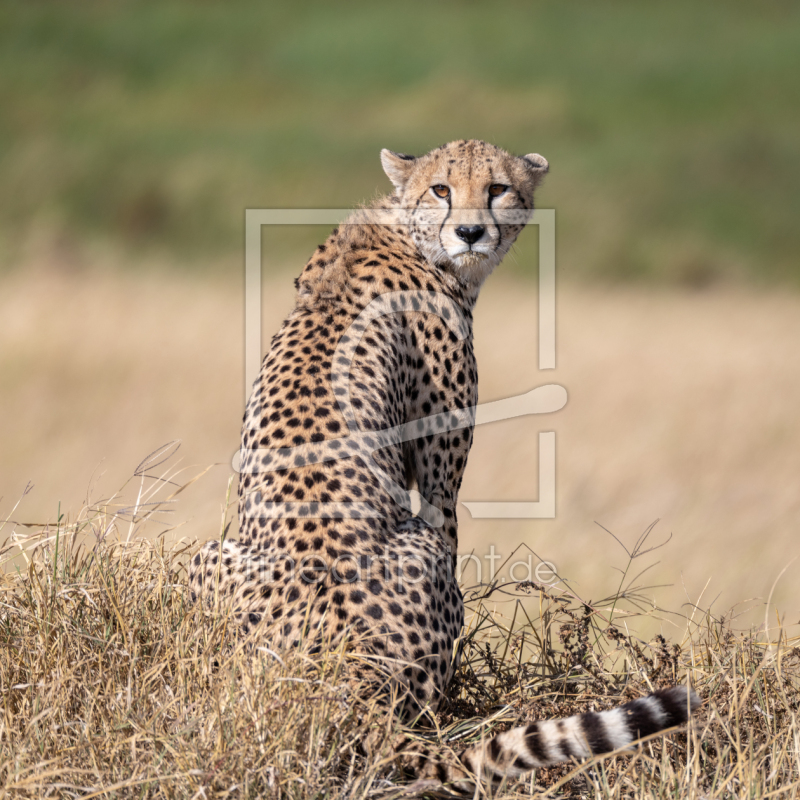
[{"xmin": 0, "ymin": 264, "xmax": 800, "ymax": 638}]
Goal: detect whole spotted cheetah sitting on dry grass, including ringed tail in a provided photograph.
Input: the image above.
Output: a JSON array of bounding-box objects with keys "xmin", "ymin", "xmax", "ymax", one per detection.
[{"xmin": 190, "ymin": 140, "xmax": 699, "ymax": 786}]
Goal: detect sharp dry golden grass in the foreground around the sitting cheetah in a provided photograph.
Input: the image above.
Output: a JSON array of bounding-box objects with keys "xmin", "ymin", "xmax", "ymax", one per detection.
[{"xmin": 0, "ymin": 452, "xmax": 800, "ymax": 800}]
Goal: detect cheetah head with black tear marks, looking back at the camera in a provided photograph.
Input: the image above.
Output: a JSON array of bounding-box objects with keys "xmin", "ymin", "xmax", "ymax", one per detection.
[{"xmin": 381, "ymin": 139, "xmax": 548, "ymax": 289}]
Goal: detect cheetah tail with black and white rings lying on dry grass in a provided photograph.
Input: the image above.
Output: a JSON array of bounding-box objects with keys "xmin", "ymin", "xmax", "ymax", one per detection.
[{"xmin": 404, "ymin": 686, "xmax": 701, "ymax": 791}]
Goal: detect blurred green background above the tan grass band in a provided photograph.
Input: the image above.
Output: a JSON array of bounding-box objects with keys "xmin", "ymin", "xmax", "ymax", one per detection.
[{"xmin": 0, "ymin": 0, "xmax": 800, "ymax": 286}]
